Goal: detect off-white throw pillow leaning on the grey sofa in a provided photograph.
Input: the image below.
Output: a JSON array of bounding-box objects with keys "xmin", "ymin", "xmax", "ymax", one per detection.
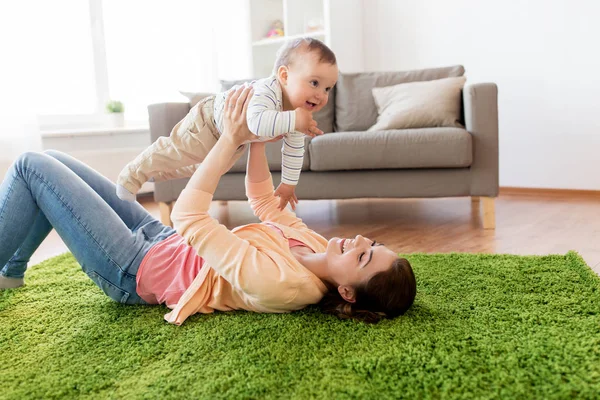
[{"xmin": 369, "ymin": 76, "xmax": 467, "ymax": 131}]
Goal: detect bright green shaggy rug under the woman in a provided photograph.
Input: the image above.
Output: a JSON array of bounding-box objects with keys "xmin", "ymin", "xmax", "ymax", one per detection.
[{"xmin": 0, "ymin": 252, "xmax": 600, "ymax": 399}]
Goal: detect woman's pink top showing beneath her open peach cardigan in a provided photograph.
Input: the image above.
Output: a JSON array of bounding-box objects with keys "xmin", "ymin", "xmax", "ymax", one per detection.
[{"xmin": 136, "ymin": 223, "xmax": 306, "ymax": 308}]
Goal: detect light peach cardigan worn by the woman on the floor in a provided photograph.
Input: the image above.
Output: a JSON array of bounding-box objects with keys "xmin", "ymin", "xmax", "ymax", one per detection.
[{"xmin": 165, "ymin": 176, "xmax": 327, "ymax": 325}]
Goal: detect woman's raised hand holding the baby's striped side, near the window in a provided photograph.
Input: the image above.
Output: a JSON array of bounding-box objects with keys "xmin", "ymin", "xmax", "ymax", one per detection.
[{"xmin": 222, "ymin": 85, "xmax": 257, "ymax": 146}]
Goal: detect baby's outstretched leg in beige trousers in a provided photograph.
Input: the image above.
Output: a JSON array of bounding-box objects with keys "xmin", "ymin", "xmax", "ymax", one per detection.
[{"xmin": 117, "ymin": 97, "xmax": 218, "ymax": 201}]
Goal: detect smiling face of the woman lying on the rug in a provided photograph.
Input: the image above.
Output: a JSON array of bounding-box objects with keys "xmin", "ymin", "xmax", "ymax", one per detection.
[{"xmin": 326, "ymin": 235, "xmax": 398, "ymax": 294}]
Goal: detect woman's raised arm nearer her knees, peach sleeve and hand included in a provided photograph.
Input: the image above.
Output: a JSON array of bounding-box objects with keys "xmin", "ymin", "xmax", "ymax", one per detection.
[{"xmin": 171, "ymin": 89, "xmax": 280, "ymax": 298}]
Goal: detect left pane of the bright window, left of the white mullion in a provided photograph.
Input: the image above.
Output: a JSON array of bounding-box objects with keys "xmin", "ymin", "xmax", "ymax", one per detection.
[{"xmin": 6, "ymin": 0, "xmax": 96, "ymax": 115}]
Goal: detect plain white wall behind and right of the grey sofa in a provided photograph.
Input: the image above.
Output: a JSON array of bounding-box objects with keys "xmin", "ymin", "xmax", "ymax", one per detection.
[{"xmin": 364, "ymin": 0, "xmax": 600, "ymax": 190}]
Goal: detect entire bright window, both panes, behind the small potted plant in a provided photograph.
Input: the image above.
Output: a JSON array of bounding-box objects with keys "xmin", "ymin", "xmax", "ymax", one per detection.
[{"xmin": 22, "ymin": 0, "xmax": 227, "ymax": 129}]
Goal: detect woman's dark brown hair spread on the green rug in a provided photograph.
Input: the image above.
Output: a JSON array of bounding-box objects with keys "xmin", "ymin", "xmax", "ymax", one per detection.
[{"xmin": 319, "ymin": 257, "xmax": 417, "ymax": 323}]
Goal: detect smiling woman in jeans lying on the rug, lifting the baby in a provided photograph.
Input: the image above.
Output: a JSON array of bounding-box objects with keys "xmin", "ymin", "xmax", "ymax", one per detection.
[{"xmin": 0, "ymin": 87, "xmax": 416, "ymax": 324}]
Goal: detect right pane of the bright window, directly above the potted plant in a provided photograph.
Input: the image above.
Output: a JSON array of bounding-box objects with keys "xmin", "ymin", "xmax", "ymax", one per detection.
[{"xmin": 103, "ymin": 0, "xmax": 219, "ymax": 120}]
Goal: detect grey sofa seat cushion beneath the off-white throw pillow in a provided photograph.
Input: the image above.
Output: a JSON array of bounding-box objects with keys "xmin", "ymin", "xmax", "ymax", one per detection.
[{"xmin": 309, "ymin": 127, "xmax": 473, "ymax": 171}]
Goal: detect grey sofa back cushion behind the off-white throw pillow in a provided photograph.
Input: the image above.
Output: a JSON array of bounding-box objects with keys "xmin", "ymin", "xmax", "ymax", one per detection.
[{"xmin": 334, "ymin": 65, "xmax": 465, "ymax": 132}]
